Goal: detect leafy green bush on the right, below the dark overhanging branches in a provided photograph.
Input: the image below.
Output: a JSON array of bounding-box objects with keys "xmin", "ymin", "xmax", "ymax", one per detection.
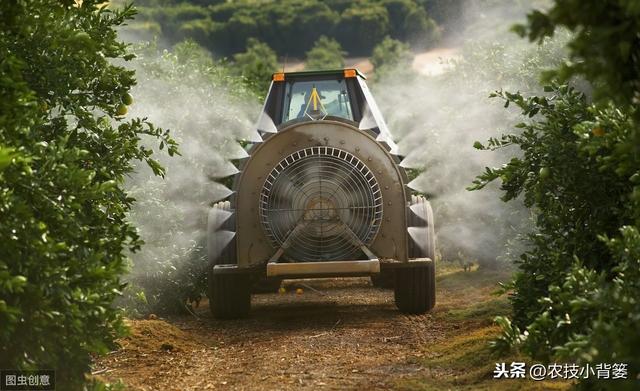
[{"xmin": 472, "ymin": 86, "xmax": 640, "ymax": 389}]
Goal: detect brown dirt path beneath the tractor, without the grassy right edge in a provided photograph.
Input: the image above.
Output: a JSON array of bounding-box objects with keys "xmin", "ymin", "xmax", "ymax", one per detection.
[{"xmin": 94, "ymin": 279, "xmax": 476, "ymax": 390}]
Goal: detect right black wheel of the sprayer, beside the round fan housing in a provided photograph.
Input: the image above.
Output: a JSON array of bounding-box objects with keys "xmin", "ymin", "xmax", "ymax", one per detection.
[{"xmin": 394, "ymin": 196, "xmax": 436, "ymax": 314}]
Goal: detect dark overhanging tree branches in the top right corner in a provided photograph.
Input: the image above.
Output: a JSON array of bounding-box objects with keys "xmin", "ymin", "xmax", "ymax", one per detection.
[{"xmin": 513, "ymin": 0, "xmax": 640, "ymax": 105}]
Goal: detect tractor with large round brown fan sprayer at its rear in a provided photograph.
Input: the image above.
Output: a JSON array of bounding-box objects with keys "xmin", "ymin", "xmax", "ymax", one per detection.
[{"xmin": 207, "ymin": 69, "xmax": 435, "ymax": 319}]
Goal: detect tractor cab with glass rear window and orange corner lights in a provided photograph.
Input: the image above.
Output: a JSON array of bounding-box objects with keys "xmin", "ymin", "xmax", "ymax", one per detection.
[{"xmin": 258, "ymin": 69, "xmax": 395, "ymax": 149}]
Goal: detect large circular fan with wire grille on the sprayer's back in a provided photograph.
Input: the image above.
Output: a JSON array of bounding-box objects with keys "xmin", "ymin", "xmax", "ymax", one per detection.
[{"xmin": 260, "ymin": 147, "xmax": 382, "ymax": 262}]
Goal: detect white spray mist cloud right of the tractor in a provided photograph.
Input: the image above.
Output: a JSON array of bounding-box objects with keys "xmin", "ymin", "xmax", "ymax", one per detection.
[{"xmin": 374, "ymin": 1, "xmax": 565, "ymax": 266}]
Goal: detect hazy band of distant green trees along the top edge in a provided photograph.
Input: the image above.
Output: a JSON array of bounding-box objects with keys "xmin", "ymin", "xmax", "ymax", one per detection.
[{"xmin": 132, "ymin": 0, "xmax": 442, "ymax": 56}]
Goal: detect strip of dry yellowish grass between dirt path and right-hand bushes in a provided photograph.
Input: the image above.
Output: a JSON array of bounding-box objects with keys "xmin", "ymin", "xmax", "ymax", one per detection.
[{"xmin": 395, "ymin": 266, "xmax": 571, "ymax": 390}]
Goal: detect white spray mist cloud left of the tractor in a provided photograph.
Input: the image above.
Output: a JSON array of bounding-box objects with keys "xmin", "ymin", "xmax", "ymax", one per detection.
[{"xmin": 119, "ymin": 43, "xmax": 260, "ymax": 311}]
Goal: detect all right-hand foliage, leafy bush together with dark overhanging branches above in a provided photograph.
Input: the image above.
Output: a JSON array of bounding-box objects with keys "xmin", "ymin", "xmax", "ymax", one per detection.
[{"xmin": 472, "ymin": 0, "xmax": 640, "ymax": 390}]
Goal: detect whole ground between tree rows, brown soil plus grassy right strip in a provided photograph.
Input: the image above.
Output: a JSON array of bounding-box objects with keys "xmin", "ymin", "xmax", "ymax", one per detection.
[{"xmin": 94, "ymin": 270, "xmax": 568, "ymax": 390}]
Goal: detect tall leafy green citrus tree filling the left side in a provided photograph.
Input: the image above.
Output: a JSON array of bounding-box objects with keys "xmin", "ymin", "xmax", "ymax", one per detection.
[{"xmin": 0, "ymin": 0, "xmax": 176, "ymax": 390}]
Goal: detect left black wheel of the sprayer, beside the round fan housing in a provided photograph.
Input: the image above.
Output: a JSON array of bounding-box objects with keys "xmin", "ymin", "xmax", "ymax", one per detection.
[{"xmin": 207, "ymin": 201, "xmax": 251, "ymax": 319}]
